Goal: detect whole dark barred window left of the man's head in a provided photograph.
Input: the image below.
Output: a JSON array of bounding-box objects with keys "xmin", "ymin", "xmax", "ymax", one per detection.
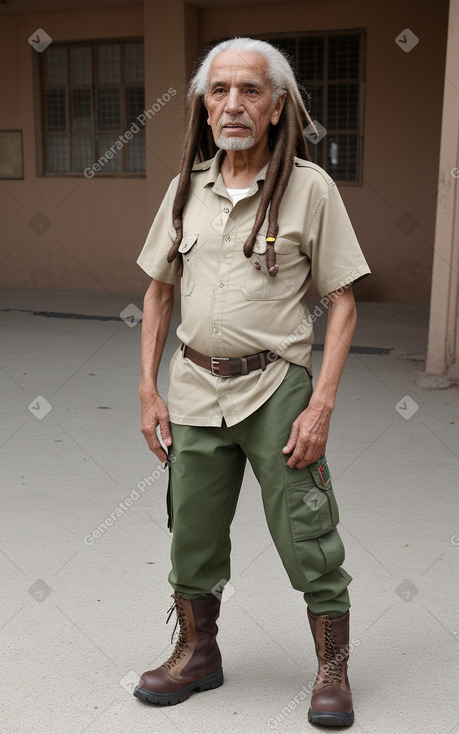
[{"xmin": 40, "ymin": 41, "xmax": 145, "ymax": 176}]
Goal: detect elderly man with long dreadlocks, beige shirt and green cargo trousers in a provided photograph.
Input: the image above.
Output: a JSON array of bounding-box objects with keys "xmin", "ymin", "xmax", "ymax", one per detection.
[{"xmin": 134, "ymin": 38, "xmax": 370, "ymax": 726}]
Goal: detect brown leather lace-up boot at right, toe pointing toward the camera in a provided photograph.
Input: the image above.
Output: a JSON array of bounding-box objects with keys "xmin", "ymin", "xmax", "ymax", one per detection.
[{"xmin": 308, "ymin": 609, "xmax": 354, "ymax": 726}]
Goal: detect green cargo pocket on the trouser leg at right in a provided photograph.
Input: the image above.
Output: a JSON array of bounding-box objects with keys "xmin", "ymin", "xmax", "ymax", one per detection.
[{"xmin": 284, "ymin": 456, "xmax": 344, "ymax": 582}]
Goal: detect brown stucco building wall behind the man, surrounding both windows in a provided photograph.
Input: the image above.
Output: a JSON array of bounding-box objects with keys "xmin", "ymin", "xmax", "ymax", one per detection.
[{"xmin": 0, "ymin": 0, "xmax": 448, "ymax": 303}]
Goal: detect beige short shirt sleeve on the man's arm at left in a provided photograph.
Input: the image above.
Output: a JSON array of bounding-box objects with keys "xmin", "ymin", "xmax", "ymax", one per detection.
[{"xmin": 137, "ymin": 177, "xmax": 181, "ymax": 285}]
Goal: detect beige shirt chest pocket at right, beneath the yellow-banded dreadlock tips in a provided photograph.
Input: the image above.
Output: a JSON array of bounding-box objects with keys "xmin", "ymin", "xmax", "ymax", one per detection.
[{"xmin": 241, "ymin": 235, "xmax": 302, "ymax": 301}]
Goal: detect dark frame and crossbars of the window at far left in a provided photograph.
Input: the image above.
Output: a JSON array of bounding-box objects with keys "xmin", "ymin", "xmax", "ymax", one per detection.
[{"xmin": 38, "ymin": 36, "xmax": 146, "ymax": 178}]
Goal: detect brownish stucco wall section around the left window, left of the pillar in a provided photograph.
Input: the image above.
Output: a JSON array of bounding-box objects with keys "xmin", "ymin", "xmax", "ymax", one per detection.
[{"xmin": 0, "ymin": 5, "xmax": 178, "ymax": 292}]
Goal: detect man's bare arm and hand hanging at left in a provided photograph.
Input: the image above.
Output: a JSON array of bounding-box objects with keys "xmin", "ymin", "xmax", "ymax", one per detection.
[{"xmin": 139, "ymin": 279, "xmax": 174, "ymax": 462}]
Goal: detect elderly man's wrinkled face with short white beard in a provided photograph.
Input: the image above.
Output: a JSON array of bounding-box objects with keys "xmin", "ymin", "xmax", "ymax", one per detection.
[{"xmin": 205, "ymin": 49, "xmax": 285, "ymax": 150}]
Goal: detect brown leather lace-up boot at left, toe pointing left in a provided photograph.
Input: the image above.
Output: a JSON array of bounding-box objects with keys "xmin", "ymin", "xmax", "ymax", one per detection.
[{"xmin": 134, "ymin": 594, "xmax": 223, "ymax": 706}]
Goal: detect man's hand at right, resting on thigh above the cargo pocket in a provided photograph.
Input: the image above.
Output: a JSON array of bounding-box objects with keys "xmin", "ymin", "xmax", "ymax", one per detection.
[{"xmin": 282, "ymin": 403, "xmax": 332, "ymax": 469}]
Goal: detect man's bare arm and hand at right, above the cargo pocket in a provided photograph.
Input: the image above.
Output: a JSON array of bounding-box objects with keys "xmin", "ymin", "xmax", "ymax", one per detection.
[{"xmin": 283, "ymin": 286, "xmax": 357, "ymax": 469}]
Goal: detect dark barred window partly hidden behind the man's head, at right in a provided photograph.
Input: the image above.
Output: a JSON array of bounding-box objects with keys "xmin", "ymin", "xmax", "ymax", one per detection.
[{"xmin": 263, "ymin": 30, "xmax": 365, "ymax": 183}]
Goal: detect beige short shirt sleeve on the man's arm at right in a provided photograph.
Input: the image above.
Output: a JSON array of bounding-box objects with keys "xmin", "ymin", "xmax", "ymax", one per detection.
[{"xmin": 305, "ymin": 182, "xmax": 371, "ymax": 296}]
